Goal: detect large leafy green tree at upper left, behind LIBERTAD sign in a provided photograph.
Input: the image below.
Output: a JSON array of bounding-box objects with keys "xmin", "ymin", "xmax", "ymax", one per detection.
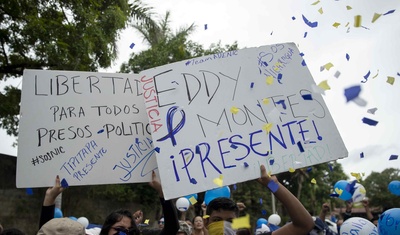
[{"xmin": 0, "ymin": 0, "xmax": 151, "ymax": 136}]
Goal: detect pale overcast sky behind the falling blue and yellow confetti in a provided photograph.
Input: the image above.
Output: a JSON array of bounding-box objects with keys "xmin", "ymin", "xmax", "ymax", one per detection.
[{"xmin": 0, "ymin": 0, "xmax": 400, "ymax": 180}]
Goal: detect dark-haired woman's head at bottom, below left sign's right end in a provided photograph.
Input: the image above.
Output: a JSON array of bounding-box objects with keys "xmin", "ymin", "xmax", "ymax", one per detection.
[{"xmin": 100, "ymin": 209, "xmax": 139, "ymax": 235}]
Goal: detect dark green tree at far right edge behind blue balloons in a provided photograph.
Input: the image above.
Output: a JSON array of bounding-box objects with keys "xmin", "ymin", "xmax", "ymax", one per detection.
[{"xmin": 361, "ymin": 168, "xmax": 400, "ymax": 209}]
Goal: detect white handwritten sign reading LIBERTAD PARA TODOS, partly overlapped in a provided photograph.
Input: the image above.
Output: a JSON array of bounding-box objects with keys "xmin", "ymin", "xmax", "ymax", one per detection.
[{"xmin": 17, "ymin": 70, "xmax": 157, "ymax": 187}]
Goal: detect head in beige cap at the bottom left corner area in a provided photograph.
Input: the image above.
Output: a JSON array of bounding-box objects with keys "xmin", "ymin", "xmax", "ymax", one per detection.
[{"xmin": 37, "ymin": 218, "xmax": 86, "ymax": 235}]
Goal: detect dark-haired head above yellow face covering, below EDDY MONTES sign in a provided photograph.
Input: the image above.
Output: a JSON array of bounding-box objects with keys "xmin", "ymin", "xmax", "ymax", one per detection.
[{"xmin": 205, "ymin": 197, "xmax": 239, "ymax": 226}]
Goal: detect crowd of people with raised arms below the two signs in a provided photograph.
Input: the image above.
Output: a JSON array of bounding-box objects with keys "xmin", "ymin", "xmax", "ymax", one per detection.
[{"xmin": 0, "ymin": 165, "xmax": 390, "ymax": 235}]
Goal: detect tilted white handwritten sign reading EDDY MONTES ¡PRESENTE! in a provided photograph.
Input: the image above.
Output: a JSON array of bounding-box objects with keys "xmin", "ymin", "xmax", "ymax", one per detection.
[{"xmin": 140, "ymin": 43, "xmax": 348, "ymax": 199}]
